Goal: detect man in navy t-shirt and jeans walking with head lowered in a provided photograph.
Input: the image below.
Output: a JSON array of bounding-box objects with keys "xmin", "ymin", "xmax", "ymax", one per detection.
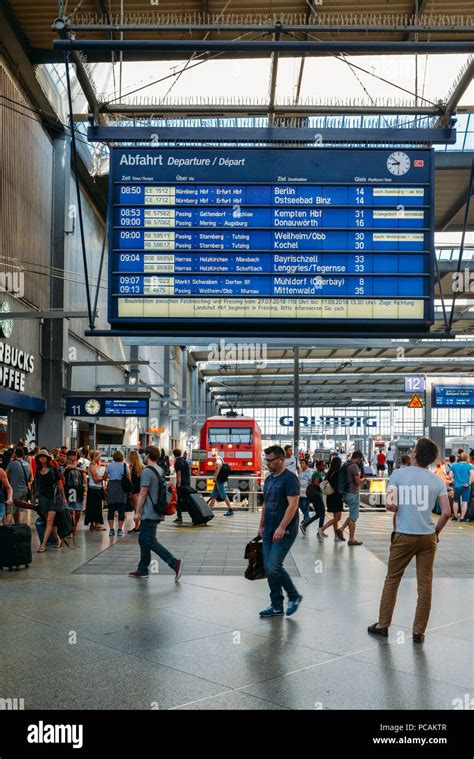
[{"xmin": 258, "ymin": 445, "xmax": 303, "ymax": 617}]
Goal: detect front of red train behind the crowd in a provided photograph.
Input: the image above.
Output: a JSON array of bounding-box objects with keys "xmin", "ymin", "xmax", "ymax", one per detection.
[{"xmin": 199, "ymin": 416, "xmax": 262, "ymax": 476}]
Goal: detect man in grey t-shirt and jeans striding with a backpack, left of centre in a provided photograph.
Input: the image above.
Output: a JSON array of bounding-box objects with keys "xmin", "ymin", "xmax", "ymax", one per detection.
[{"xmin": 129, "ymin": 445, "xmax": 183, "ymax": 582}]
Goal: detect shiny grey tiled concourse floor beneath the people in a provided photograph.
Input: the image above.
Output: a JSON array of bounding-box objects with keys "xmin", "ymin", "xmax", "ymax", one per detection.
[{"xmin": 0, "ymin": 510, "xmax": 474, "ymax": 710}]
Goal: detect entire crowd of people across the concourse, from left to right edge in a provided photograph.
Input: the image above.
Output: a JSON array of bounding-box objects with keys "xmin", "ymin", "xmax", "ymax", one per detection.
[{"xmin": 0, "ymin": 438, "xmax": 474, "ymax": 642}]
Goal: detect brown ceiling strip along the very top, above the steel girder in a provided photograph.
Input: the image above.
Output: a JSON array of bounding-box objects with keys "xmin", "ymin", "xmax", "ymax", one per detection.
[{"xmin": 6, "ymin": 0, "xmax": 474, "ymax": 52}]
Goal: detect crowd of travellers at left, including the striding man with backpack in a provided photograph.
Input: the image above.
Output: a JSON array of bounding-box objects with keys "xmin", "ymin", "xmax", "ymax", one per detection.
[{"xmin": 0, "ymin": 441, "xmax": 186, "ymax": 579}]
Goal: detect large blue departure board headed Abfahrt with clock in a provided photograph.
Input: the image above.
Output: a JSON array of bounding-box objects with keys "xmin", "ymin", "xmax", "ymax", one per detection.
[{"xmin": 109, "ymin": 147, "xmax": 434, "ymax": 335}]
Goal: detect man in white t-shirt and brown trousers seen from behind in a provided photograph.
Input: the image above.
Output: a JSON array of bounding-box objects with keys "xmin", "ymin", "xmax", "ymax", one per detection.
[{"xmin": 368, "ymin": 438, "xmax": 451, "ymax": 643}]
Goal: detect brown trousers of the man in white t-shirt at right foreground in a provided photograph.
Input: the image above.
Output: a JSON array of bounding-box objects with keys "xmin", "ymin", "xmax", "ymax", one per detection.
[{"xmin": 379, "ymin": 532, "xmax": 437, "ymax": 634}]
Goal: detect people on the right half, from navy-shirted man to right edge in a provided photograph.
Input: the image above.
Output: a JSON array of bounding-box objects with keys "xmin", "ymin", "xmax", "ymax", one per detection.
[{"xmin": 259, "ymin": 438, "xmax": 474, "ymax": 643}]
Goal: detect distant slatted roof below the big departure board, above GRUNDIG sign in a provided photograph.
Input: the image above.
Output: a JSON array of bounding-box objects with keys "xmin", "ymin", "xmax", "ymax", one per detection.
[{"xmin": 191, "ymin": 336, "xmax": 474, "ymax": 409}]
